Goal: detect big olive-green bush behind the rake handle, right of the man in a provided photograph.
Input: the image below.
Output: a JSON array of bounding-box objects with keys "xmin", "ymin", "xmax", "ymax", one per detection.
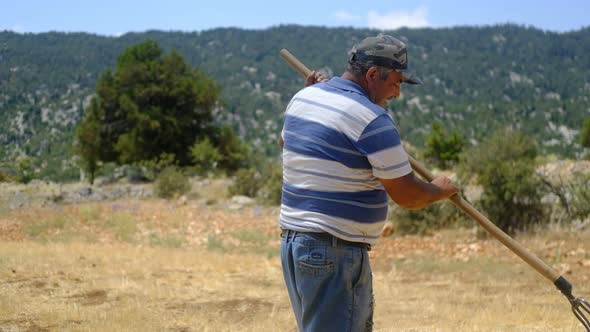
[{"xmin": 459, "ymin": 129, "xmax": 544, "ymax": 232}]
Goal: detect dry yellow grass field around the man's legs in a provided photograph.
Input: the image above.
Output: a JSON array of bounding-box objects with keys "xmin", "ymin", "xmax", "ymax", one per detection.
[{"xmin": 0, "ymin": 180, "xmax": 590, "ymax": 332}]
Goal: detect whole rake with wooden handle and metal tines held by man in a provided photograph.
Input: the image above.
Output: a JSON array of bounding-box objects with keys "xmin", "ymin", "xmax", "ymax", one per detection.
[{"xmin": 279, "ymin": 49, "xmax": 590, "ymax": 332}]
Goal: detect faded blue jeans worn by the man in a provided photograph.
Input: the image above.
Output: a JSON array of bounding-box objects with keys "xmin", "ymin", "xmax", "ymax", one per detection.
[{"xmin": 281, "ymin": 230, "xmax": 373, "ymax": 332}]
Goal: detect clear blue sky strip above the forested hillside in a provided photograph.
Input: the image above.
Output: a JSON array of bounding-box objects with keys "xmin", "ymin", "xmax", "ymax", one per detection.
[{"xmin": 0, "ymin": 0, "xmax": 590, "ymax": 35}]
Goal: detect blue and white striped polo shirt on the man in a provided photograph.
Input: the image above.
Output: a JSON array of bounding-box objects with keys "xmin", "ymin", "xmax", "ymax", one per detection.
[{"xmin": 279, "ymin": 77, "xmax": 412, "ymax": 244}]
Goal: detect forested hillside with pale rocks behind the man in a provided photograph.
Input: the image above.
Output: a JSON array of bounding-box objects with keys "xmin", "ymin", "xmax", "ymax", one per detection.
[{"xmin": 0, "ymin": 25, "xmax": 590, "ymax": 178}]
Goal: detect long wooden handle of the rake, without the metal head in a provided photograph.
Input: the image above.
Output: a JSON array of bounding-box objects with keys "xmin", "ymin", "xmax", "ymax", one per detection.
[{"xmin": 279, "ymin": 49, "xmax": 560, "ymax": 283}]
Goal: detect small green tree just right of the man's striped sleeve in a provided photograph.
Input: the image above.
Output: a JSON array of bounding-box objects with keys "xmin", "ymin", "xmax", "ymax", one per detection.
[{"xmin": 424, "ymin": 122, "xmax": 465, "ymax": 168}]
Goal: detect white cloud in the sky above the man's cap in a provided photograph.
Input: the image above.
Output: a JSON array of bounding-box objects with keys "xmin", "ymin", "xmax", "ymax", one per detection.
[{"xmin": 367, "ymin": 7, "xmax": 431, "ymax": 30}]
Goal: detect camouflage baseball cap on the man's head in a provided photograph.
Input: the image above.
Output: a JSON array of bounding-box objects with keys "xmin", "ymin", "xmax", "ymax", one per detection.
[{"xmin": 348, "ymin": 35, "xmax": 422, "ymax": 84}]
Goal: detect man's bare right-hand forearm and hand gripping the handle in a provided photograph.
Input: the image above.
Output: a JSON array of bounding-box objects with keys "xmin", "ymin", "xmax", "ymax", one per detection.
[{"xmin": 379, "ymin": 172, "xmax": 459, "ymax": 210}]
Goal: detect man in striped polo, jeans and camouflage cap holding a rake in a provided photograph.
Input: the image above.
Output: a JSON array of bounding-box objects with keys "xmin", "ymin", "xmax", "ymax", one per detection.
[{"xmin": 279, "ymin": 35, "xmax": 457, "ymax": 332}]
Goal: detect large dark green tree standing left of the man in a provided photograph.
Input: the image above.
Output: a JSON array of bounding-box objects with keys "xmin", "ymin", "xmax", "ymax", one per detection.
[{"xmin": 77, "ymin": 41, "xmax": 220, "ymax": 176}]
